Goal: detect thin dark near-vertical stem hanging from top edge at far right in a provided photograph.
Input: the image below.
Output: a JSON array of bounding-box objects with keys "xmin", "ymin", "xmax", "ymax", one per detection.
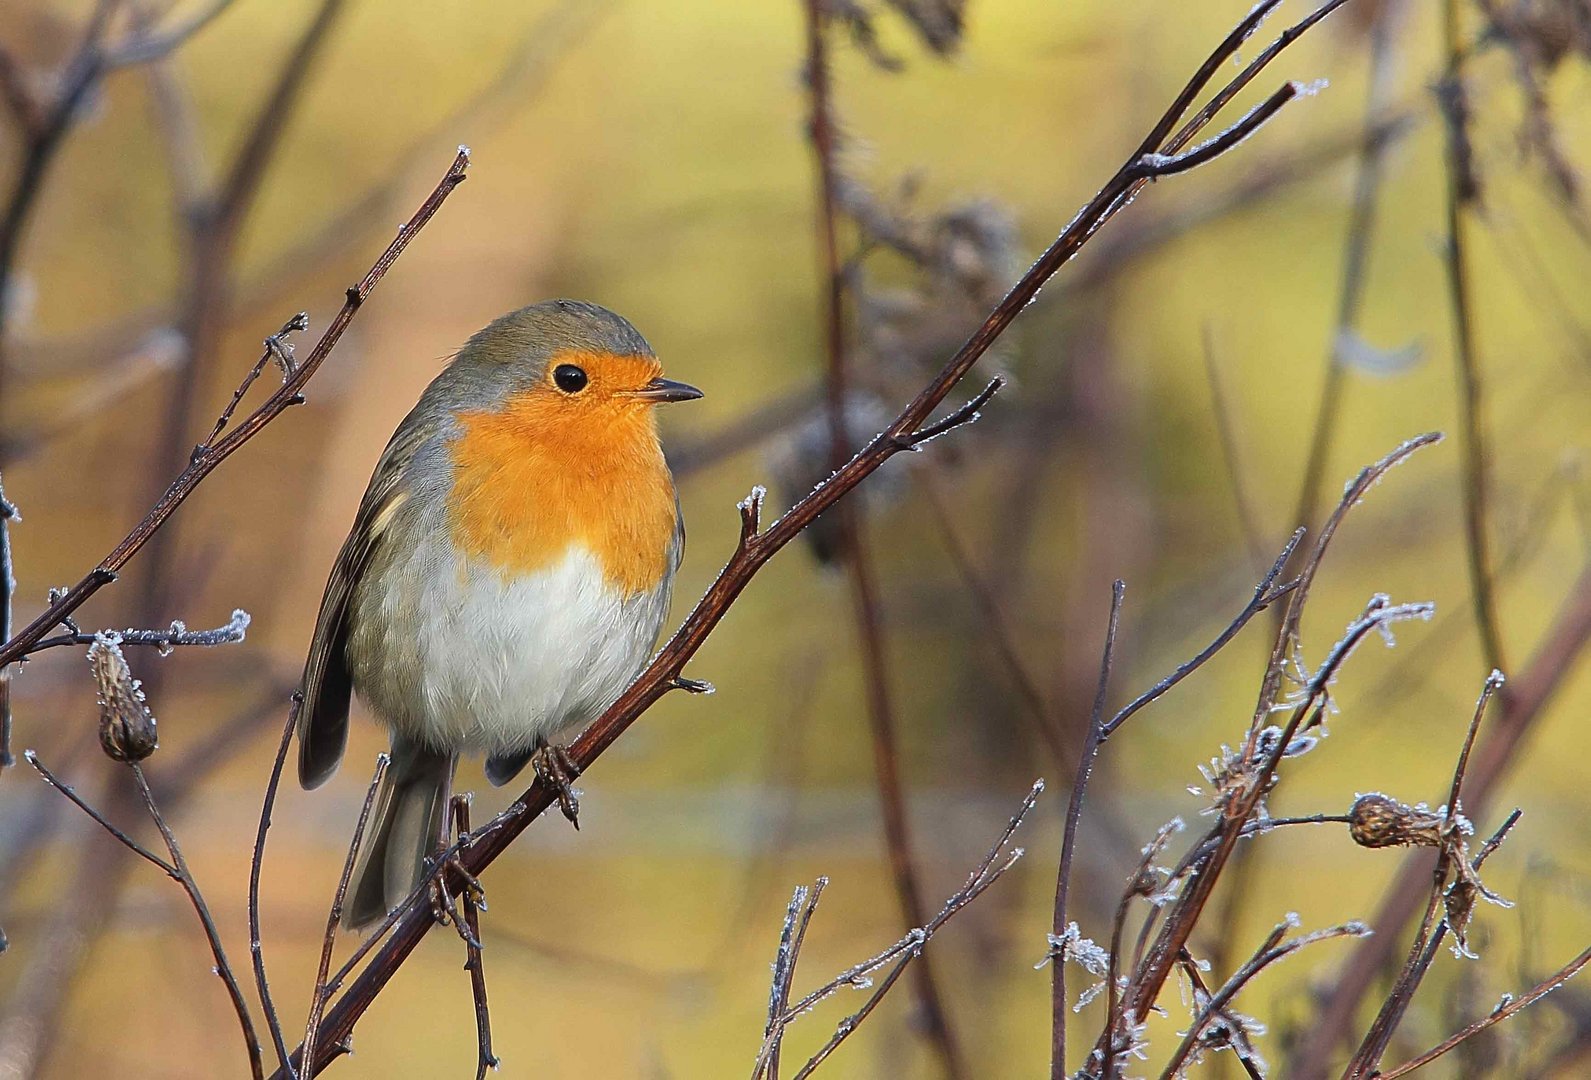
[{"xmin": 1440, "ymin": 0, "xmax": 1508, "ymax": 671}]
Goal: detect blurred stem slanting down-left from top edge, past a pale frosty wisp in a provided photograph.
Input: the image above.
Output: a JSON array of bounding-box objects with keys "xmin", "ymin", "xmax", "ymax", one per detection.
[{"xmin": 1293, "ymin": 3, "xmax": 1398, "ymax": 540}]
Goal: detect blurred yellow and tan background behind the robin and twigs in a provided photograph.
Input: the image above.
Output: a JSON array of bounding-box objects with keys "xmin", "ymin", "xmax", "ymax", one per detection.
[{"xmin": 0, "ymin": 0, "xmax": 1591, "ymax": 1077}]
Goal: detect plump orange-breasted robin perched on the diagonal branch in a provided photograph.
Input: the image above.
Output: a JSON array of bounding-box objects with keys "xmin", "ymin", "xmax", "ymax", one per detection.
[{"xmin": 298, "ymin": 301, "xmax": 702, "ymax": 929}]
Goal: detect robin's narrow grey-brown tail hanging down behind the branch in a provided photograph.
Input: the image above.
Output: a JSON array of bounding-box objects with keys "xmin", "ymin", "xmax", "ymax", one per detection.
[{"xmin": 342, "ymin": 735, "xmax": 458, "ymax": 930}]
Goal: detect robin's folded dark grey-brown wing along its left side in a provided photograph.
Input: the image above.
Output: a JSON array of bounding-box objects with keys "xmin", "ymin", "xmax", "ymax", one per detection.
[{"xmin": 298, "ymin": 415, "xmax": 430, "ymax": 789}]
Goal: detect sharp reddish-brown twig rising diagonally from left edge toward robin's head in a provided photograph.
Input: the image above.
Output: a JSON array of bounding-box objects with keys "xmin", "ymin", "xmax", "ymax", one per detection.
[{"xmin": 0, "ymin": 148, "xmax": 469, "ymax": 665}]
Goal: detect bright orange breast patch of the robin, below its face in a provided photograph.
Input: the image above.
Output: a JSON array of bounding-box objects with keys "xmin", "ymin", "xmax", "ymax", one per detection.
[{"xmin": 449, "ymin": 391, "xmax": 675, "ymax": 596}]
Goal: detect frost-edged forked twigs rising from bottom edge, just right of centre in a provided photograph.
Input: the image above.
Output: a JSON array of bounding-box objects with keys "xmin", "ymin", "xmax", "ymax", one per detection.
[{"xmin": 751, "ymin": 779, "xmax": 1044, "ymax": 1080}]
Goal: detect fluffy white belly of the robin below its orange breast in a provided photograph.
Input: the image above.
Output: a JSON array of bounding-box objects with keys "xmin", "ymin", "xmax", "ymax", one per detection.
[{"xmin": 350, "ymin": 544, "xmax": 668, "ymax": 754}]
